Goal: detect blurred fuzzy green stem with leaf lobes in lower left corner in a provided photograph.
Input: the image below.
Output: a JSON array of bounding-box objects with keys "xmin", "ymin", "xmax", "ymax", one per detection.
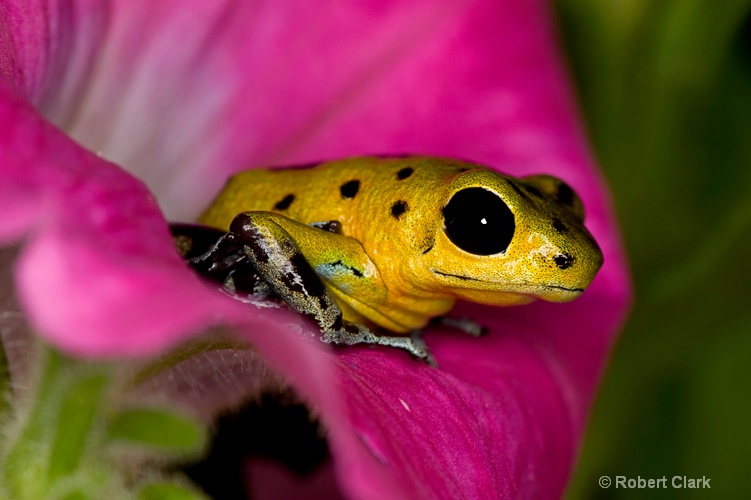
[{"xmin": 0, "ymin": 345, "xmax": 214, "ymax": 500}]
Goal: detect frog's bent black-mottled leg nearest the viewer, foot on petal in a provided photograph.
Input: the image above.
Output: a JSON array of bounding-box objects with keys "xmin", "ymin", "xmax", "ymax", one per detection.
[{"xmin": 230, "ymin": 212, "xmax": 433, "ymax": 364}]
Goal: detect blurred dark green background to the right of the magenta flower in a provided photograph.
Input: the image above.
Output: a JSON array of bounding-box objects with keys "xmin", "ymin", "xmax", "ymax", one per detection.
[{"xmin": 557, "ymin": 0, "xmax": 751, "ymax": 499}]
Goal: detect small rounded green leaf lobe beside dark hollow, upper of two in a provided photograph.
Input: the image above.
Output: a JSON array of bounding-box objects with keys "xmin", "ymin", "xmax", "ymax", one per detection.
[{"xmin": 109, "ymin": 408, "xmax": 206, "ymax": 453}]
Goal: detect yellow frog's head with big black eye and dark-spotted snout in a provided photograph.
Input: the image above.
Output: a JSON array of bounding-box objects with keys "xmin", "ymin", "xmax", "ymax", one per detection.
[{"xmin": 423, "ymin": 168, "xmax": 603, "ymax": 305}]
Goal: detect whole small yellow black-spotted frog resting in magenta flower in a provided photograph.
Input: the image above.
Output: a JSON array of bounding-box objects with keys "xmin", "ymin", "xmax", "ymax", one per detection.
[{"xmin": 173, "ymin": 155, "xmax": 603, "ymax": 364}]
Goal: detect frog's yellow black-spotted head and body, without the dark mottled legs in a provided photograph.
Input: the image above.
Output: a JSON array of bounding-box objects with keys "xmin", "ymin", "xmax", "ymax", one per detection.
[{"xmin": 200, "ymin": 157, "xmax": 602, "ymax": 334}]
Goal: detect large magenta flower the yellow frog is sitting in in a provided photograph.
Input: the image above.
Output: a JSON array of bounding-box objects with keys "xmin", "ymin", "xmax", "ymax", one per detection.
[{"xmin": 0, "ymin": 0, "xmax": 630, "ymax": 498}]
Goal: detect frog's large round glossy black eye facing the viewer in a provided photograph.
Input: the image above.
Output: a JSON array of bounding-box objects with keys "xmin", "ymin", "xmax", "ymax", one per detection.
[{"xmin": 443, "ymin": 187, "xmax": 516, "ymax": 255}]
